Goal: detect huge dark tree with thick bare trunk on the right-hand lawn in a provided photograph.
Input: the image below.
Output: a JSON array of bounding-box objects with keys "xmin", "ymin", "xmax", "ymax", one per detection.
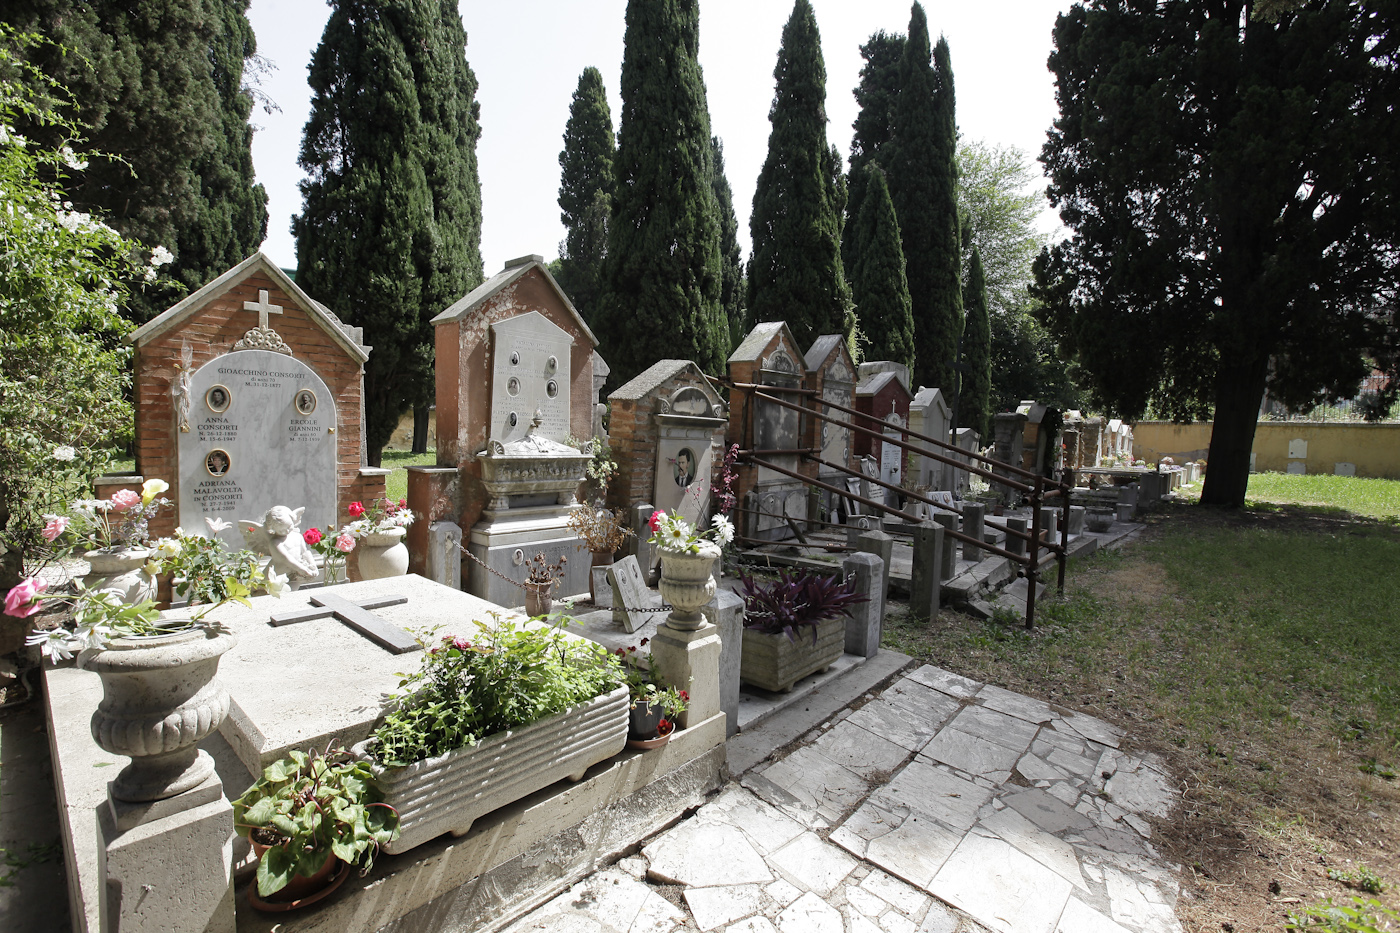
[{"xmin": 1036, "ymin": 0, "xmax": 1400, "ymax": 506}]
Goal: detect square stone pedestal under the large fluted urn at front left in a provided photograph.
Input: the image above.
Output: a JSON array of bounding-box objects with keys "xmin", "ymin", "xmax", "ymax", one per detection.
[{"xmin": 97, "ymin": 776, "xmax": 235, "ymax": 933}]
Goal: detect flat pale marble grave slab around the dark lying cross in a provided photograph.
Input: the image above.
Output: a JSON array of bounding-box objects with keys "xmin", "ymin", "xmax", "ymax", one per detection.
[{"xmin": 210, "ymin": 574, "xmax": 526, "ymax": 773}]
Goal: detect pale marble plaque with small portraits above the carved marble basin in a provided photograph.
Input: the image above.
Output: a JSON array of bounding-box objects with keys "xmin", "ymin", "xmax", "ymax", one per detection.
[{"xmin": 487, "ymin": 311, "xmax": 574, "ymax": 444}]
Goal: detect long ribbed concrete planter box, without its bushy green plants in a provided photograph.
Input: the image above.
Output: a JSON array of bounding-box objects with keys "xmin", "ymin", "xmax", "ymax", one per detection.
[{"xmin": 354, "ymin": 686, "xmax": 627, "ymax": 855}]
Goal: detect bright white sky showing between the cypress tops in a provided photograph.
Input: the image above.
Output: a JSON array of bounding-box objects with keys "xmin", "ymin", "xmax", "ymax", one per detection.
[{"xmin": 249, "ymin": 0, "xmax": 1070, "ymax": 275}]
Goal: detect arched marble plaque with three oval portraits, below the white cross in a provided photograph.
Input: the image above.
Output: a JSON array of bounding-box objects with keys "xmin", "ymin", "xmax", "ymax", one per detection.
[{"xmin": 178, "ymin": 350, "xmax": 337, "ymax": 549}]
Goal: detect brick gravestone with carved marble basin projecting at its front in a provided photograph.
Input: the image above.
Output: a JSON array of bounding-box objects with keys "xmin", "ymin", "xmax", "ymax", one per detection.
[{"xmin": 422, "ymin": 255, "xmax": 598, "ymax": 605}]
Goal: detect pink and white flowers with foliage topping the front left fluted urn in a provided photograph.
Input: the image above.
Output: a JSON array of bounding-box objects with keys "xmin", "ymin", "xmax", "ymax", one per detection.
[{"xmin": 15, "ymin": 518, "xmax": 288, "ymax": 663}]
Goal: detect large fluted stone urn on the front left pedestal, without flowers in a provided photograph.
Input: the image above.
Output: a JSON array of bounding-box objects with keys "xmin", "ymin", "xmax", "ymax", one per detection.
[{"xmin": 80, "ymin": 622, "xmax": 238, "ymax": 803}]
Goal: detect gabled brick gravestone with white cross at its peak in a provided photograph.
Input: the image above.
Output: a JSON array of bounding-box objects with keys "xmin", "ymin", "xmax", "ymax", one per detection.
[{"xmin": 126, "ymin": 246, "xmax": 389, "ymax": 551}]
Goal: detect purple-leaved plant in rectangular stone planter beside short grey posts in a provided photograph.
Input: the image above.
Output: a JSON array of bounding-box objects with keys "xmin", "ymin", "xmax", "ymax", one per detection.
[{"xmin": 739, "ymin": 570, "xmax": 867, "ymax": 692}]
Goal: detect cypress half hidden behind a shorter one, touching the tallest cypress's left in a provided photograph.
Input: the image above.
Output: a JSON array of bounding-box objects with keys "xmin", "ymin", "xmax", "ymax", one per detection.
[{"xmin": 841, "ymin": 29, "xmax": 904, "ymax": 285}]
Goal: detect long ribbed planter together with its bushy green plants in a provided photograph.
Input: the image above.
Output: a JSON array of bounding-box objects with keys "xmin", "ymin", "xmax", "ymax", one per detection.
[{"xmin": 354, "ymin": 616, "xmax": 627, "ymax": 853}]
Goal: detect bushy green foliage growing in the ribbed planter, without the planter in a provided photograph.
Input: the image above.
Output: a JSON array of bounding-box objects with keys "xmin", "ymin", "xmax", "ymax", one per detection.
[{"xmin": 368, "ymin": 616, "xmax": 622, "ymax": 768}]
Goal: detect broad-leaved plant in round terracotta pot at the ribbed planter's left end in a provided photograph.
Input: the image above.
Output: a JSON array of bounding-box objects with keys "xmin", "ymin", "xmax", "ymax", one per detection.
[{"xmin": 234, "ymin": 747, "xmax": 399, "ymax": 911}]
